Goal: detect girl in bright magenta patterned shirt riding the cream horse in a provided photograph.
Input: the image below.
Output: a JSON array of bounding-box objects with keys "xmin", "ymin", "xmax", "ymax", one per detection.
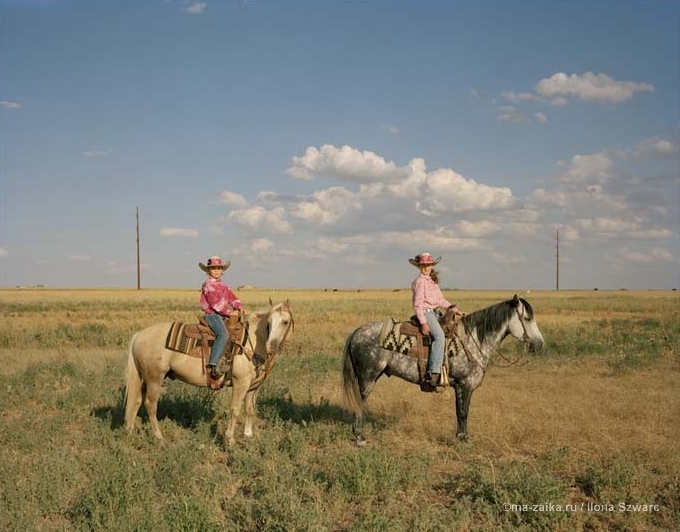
[{"xmin": 198, "ymin": 255, "xmax": 243, "ymax": 380}]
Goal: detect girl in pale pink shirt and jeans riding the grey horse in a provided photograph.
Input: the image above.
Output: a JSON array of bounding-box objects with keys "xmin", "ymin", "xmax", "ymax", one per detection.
[{"xmin": 408, "ymin": 253, "xmax": 463, "ymax": 391}]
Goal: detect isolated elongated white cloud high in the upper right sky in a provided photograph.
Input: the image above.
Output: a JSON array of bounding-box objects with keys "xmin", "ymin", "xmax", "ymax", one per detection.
[{"xmin": 536, "ymin": 72, "xmax": 654, "ymax": 103}]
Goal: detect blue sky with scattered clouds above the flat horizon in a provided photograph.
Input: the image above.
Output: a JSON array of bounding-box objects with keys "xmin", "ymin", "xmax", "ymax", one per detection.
[{"xmin": 0, "ymin": 0, "xmax": 680, "ymax": 290}]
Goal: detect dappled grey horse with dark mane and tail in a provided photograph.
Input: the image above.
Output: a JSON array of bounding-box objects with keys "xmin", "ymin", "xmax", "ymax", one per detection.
[{"xmin": 342, "ymin": 295, "xmax": 543, "ymax": 446}]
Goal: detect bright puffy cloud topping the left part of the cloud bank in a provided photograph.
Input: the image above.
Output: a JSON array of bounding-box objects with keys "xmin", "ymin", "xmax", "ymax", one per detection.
[{"xmin": 286, "ymin": 144, "xmax": 409, "ymax": 182}]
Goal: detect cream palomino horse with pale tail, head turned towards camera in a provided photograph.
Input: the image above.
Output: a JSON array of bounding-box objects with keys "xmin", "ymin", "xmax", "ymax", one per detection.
[{"xmin": 125, "ymin": 300, "xmax": 293, "ymax": 444}]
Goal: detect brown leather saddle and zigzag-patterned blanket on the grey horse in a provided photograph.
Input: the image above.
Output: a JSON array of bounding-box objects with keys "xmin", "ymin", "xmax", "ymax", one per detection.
[{"xmin": 380, "ymin": 310, "xmax": 460, "ymax": 388}]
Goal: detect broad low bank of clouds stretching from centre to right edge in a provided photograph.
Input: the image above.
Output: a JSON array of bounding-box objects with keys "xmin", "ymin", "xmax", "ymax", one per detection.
[{"xmin": 211, "ymin": 143, "xmax": 675, "ymax": 290}]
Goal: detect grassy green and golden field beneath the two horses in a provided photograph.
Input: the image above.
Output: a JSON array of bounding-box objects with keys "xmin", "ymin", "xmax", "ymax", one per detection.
[{"xmin": 0, "ymin": 289, "xmax": 680, "ymax": 532}]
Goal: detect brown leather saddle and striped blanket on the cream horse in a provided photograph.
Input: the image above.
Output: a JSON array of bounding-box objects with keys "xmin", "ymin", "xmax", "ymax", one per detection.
[{"xmin": 165, "ymin": 312, "xmax": 252, "ymax": 389}]
